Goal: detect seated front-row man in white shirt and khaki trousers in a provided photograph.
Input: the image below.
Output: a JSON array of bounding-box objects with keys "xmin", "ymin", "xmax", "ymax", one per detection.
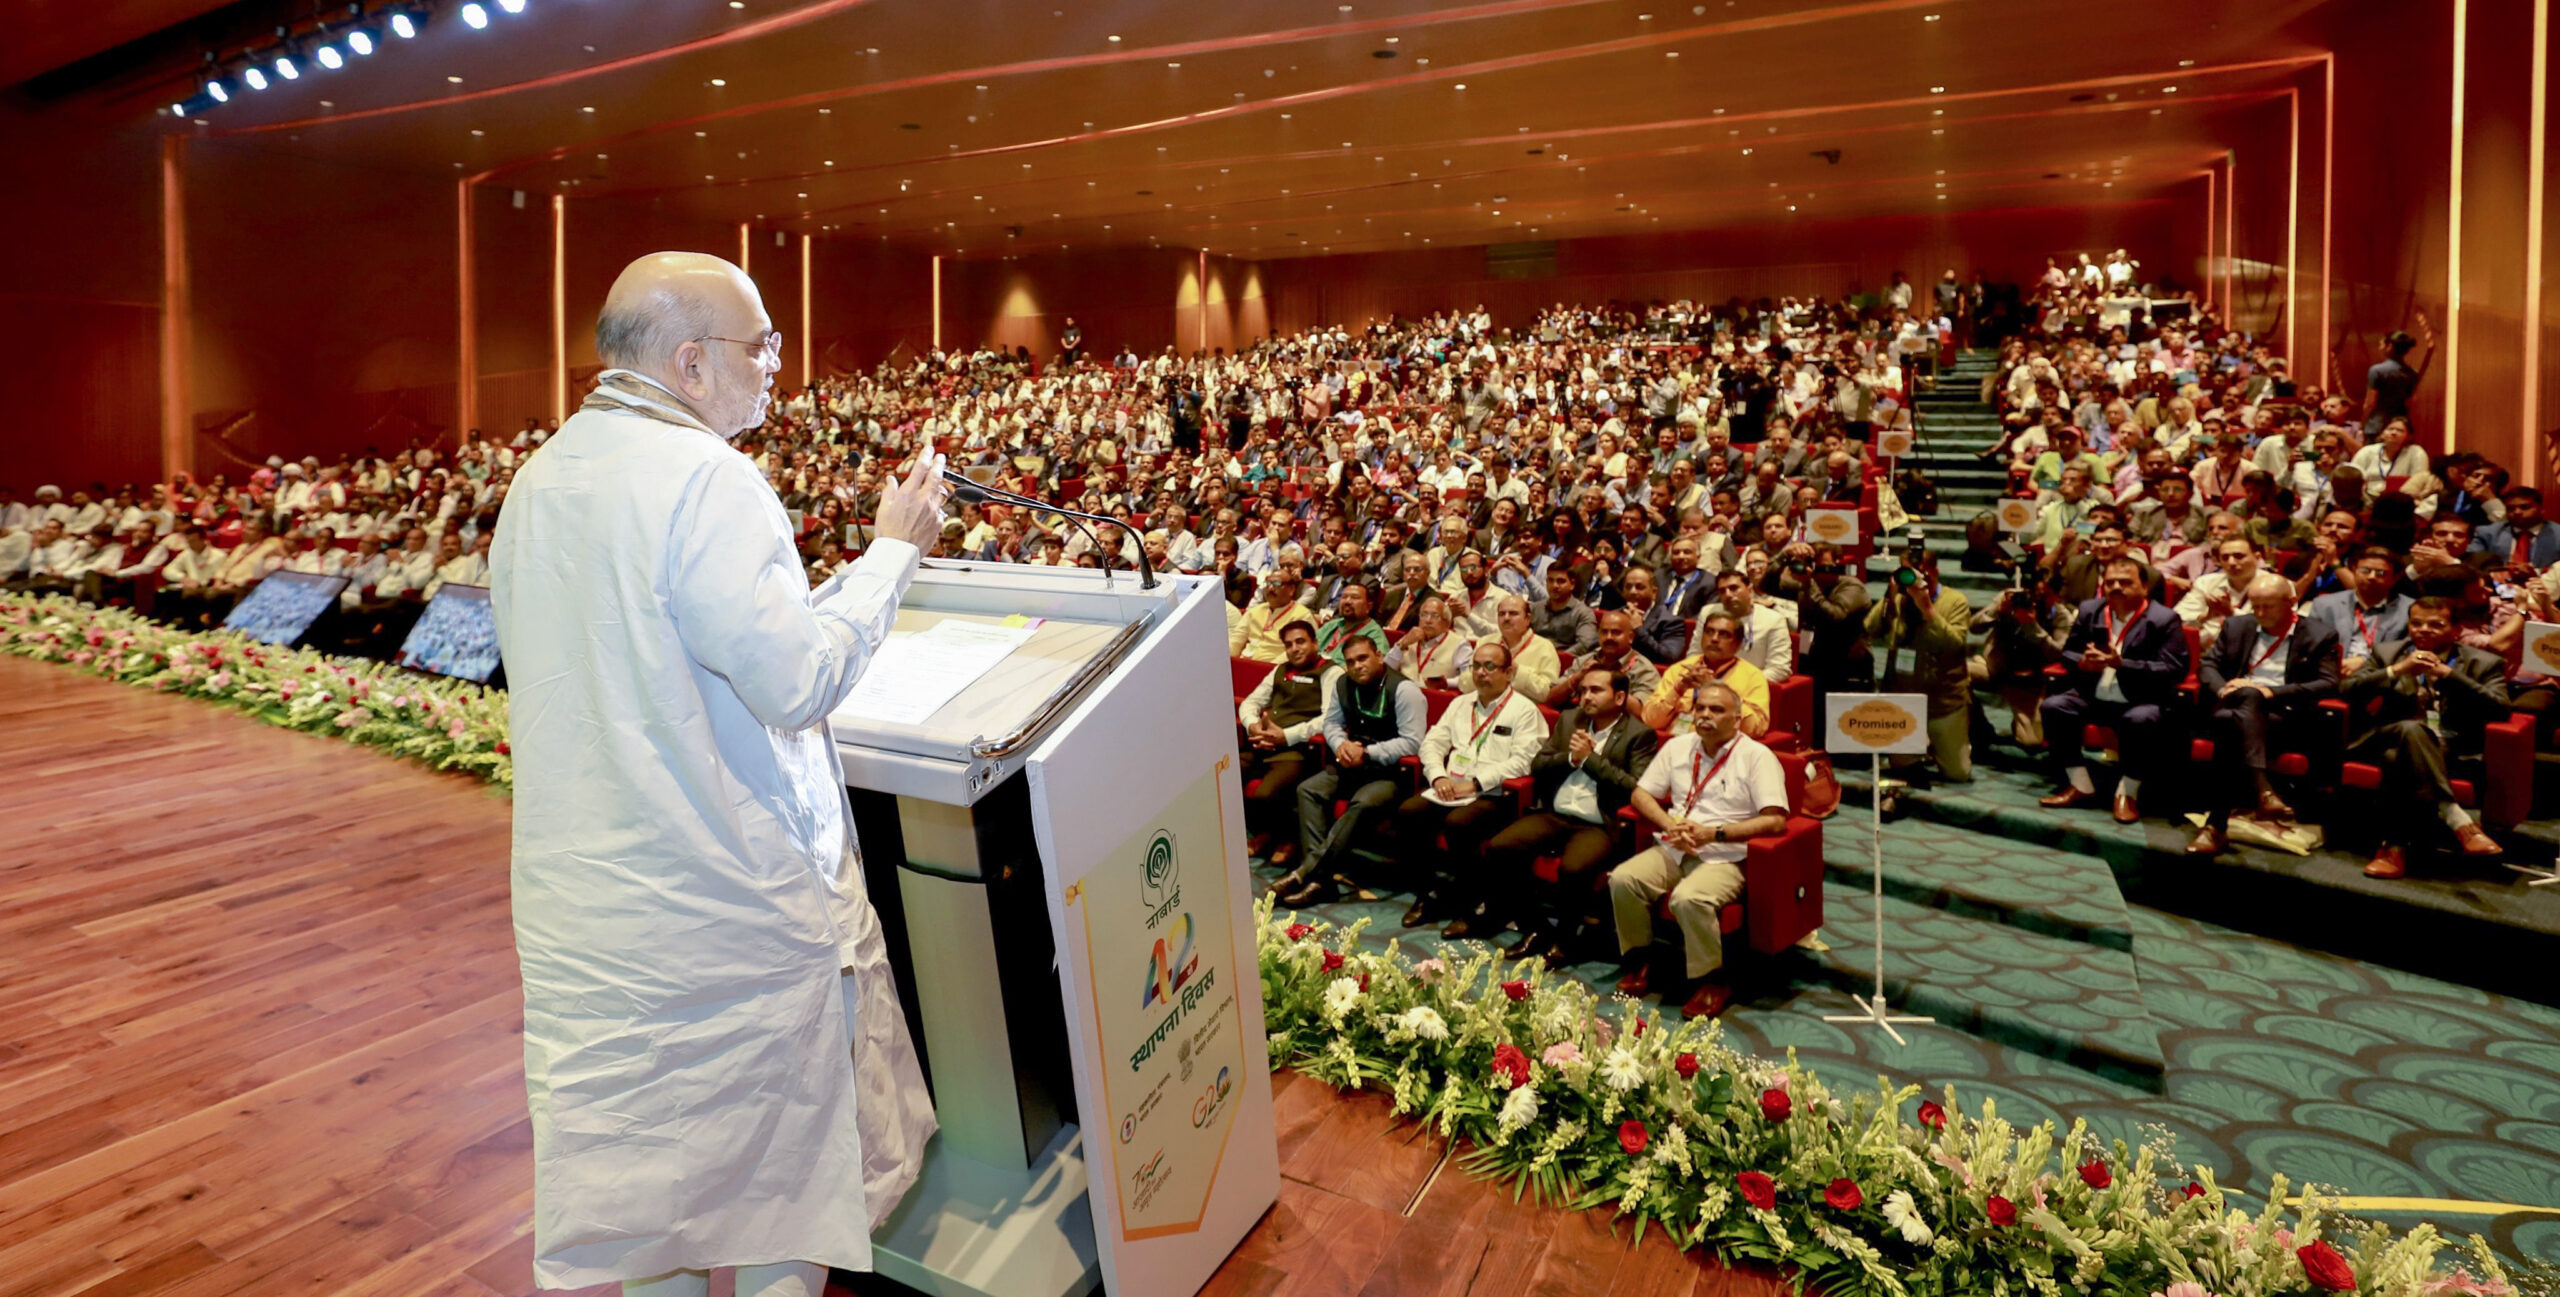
[{"xmin": 1608, "ymin": 680, "xmax": 1787, "ymax": 1018}]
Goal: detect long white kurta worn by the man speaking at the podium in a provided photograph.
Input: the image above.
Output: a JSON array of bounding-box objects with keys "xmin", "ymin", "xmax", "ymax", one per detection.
[{"xmin": 492, "ymin": 409, "xmax": 934, "ymax": 1287}]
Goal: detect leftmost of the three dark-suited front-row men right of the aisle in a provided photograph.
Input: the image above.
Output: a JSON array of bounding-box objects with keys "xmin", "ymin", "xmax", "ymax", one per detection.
[{"xmin": 2040, "ymin": 558, "xmax": 2186, "ymax": 824}]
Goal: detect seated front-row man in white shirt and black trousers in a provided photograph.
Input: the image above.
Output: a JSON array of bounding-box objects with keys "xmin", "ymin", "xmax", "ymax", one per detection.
[{"xmin": 1395, "ymin": 640, "xmax": 1546, "ymax": 941}]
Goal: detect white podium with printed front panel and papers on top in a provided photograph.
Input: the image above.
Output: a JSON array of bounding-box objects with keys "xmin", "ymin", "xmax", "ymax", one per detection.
[{"xmin": 829, "ymin": 560, "xmax": 1280, "ymax": 1297}]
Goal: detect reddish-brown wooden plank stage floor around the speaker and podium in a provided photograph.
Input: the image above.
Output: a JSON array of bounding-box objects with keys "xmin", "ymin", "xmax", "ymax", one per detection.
[{"xmin": 0, "ymin": 657, "xmax": 1774, "ymax": 1297}]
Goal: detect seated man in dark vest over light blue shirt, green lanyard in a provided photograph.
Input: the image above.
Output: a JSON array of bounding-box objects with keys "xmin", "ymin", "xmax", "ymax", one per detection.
[{"xmin": 1272, "ymin": 634, "xmax": 1431, "ymax": 906}]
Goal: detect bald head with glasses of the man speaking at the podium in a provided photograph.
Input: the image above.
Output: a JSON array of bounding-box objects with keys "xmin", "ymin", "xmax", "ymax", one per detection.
[{"xmin": 596, "ymin": 253, "xmax": 781, "ymax": 437}]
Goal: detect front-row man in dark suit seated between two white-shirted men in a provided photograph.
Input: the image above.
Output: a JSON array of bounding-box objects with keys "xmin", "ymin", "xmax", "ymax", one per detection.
[{"xmin": 1485, "ymin": 670, "xmax": 1661, "ymax": 959}]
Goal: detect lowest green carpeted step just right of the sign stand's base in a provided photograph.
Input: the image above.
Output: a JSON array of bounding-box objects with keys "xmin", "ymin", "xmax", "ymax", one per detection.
[{"xmin": 1807, "ymin": 885, "xmax": 2166, "ymax": 1092}]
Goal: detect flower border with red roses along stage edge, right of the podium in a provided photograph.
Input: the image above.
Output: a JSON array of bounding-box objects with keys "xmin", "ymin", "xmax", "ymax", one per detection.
[{"xmin": 1260, "ymin": 900, "xmax": 2514, "ymax": 1297}]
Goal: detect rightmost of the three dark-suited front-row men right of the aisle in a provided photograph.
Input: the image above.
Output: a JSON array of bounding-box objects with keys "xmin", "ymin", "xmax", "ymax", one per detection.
[{"xmin": 2340, "ymin": 599, "xmax": 2506, "ymax": 877}]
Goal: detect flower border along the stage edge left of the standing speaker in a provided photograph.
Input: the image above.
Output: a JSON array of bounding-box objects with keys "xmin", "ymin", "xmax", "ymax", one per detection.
[{"xmin": 0, "ymin": 593, "xmax": 515, "ymax": 788}]
